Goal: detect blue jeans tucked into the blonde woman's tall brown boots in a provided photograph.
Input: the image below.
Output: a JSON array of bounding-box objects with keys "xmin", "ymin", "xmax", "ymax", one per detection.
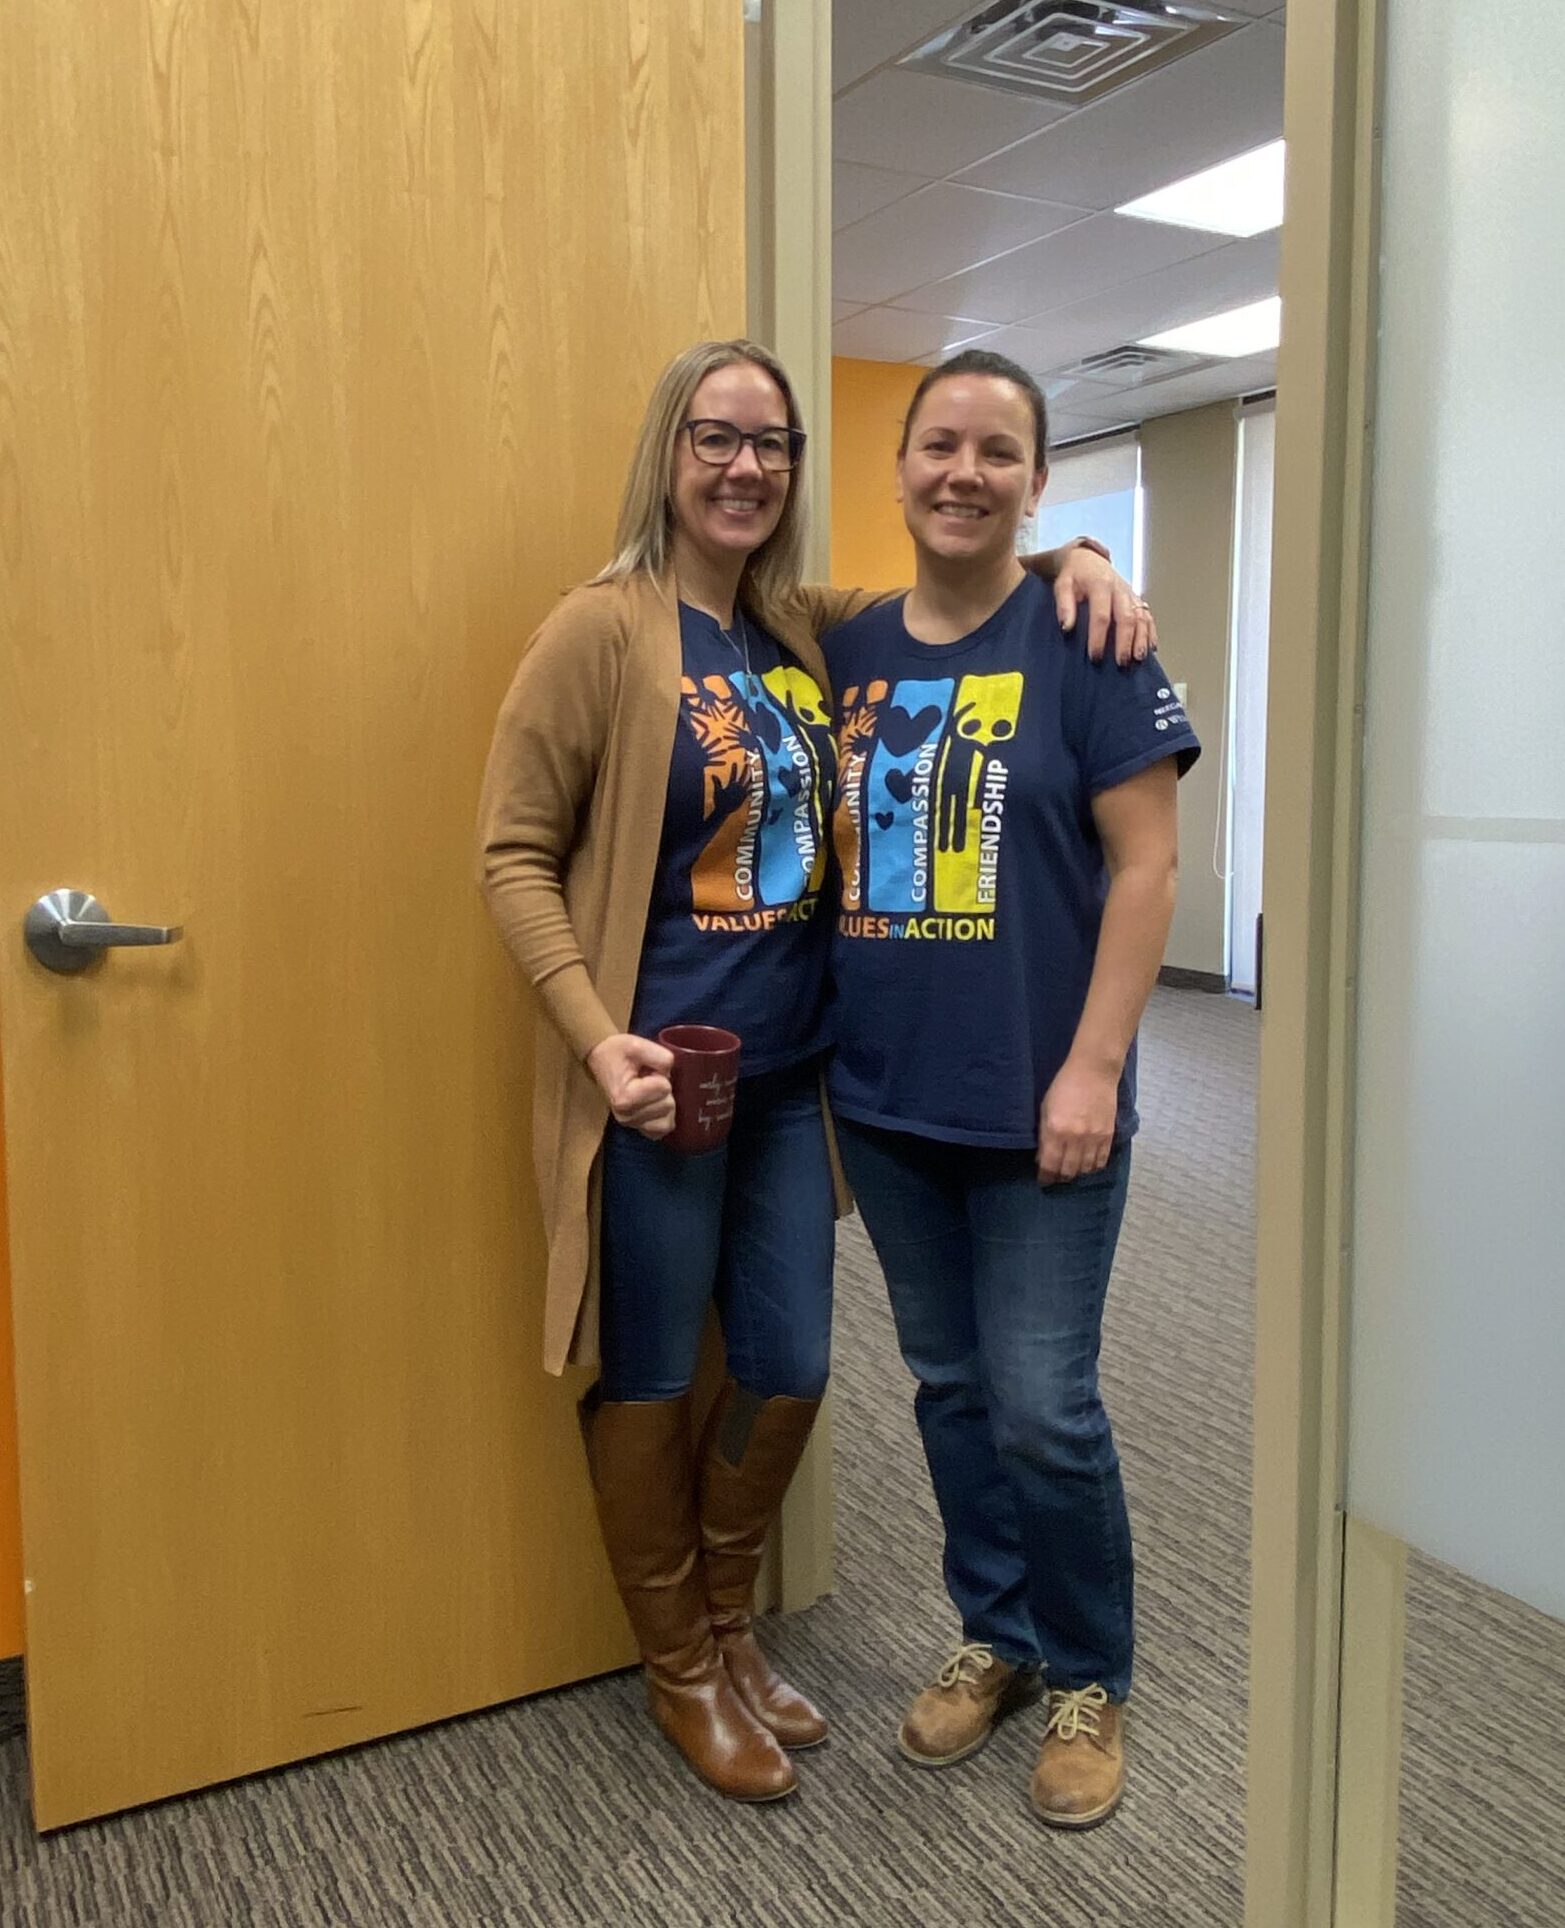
[{"xmin": 599, "ymin": 1058, "xmax": 833, "ymax": 1400}]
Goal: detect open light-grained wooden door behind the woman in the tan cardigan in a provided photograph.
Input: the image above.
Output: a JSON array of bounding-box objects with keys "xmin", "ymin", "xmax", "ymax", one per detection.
[{"xmin": 0, "ymin": 0, "xmax": 744, "ymax": 1828}]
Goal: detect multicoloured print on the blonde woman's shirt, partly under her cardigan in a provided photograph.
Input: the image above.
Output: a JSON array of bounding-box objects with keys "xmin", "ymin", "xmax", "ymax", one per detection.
[{"xmin": 680, "ymin": 665, "xmax": 829, "ymax": 931}]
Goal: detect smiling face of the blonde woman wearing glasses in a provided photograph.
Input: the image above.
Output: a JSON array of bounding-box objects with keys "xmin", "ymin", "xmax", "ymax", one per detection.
[{"xmin": 671, "ymin": 362, "xmax": 792, "ymax": 565}]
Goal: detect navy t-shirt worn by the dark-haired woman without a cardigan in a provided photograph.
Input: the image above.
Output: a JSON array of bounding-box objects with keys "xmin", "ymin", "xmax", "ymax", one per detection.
[{"xmin": 827, "ymin": 576, "xmax": 1201, "ymax": 1147}]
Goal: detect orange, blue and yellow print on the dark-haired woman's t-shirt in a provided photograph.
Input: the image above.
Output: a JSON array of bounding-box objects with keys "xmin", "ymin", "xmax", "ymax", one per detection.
[{"xmin": 833, "ymin": 671, "xmax": 1023, "ymax": 943}]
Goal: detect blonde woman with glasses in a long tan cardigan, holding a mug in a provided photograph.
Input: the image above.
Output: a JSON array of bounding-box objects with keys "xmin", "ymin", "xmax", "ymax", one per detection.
[{"xmin": 470, "ymin": 341, "xmax": 1147, "ymax": 1801}]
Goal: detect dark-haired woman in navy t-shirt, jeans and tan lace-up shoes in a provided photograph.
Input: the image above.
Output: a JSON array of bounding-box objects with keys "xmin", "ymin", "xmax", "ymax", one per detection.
[{"xmin": 825, "ymin": 349, "xmax": 1199, "ymax": 1828}]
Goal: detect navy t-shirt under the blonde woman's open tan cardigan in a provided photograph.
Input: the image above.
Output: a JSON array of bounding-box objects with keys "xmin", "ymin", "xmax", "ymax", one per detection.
[{"xmin": 630, "ymin": 603, "xmax": 835, "ymax": 1078}]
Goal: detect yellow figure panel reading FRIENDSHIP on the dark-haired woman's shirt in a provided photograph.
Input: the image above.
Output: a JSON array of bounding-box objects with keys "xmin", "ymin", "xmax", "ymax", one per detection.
[{"xmin": 935, "ymin": 669, "xmax": 1023, "ymax": 912}]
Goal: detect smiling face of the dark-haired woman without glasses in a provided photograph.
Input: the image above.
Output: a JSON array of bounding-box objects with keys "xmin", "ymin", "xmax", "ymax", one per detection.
[{"xmin": 896, "ymin": 374, "xmax": 1048, "ymax": 569}]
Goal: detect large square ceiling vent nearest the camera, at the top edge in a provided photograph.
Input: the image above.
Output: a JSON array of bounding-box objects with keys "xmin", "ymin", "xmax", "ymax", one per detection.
[{"xmin": 902, "ymin": 0, "xmax": 1247, "ymax": 108}]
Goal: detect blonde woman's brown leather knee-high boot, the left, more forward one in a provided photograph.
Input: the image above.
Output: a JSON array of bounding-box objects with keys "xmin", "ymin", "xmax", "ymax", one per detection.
[{"xmin": 582, "ymin": 1396, "xmax": 798, "ymax": 1801}]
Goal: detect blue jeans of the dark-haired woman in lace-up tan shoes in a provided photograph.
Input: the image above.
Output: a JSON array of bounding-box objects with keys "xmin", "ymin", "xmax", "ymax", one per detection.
[{"xmin": 838, "ymin": 1120, "xmax": 1133, "ymax": 1700}]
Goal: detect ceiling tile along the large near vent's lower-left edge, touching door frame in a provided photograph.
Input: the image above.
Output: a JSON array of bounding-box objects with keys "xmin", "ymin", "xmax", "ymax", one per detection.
[{"xmin": 833, "ymin": 67, "xmax": 1066, "ymax": 179}]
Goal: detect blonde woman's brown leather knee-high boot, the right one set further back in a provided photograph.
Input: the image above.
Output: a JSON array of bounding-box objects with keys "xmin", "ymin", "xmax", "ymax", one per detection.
[{"xmin": 702, "ymin": 1379, "xmax": 827, "ymax": 1747}]
